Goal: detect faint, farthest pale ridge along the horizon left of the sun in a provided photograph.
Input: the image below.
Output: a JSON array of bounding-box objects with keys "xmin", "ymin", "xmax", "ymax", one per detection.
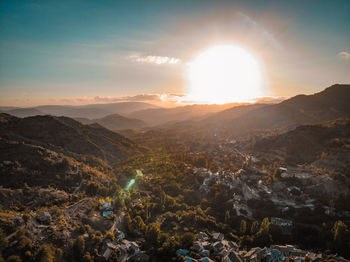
[{"xmin": 0, "ymin": 102, "xmax": 158, "ymax": 119}]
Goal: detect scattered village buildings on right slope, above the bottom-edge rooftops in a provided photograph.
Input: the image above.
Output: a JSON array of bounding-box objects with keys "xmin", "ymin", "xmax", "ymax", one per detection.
[{"xmin": 194, "ymin": 160, "xmax": 350, "ymax": 226}]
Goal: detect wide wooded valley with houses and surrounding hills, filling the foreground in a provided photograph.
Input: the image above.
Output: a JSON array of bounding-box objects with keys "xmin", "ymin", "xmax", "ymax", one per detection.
[{"xmin": 0, "ymin": 85, "xmax": 350, "ymax": 262}]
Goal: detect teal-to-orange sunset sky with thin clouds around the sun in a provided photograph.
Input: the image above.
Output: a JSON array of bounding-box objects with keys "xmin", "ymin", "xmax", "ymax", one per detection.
[{"xmin": 0, "ymin": 0, "xmax": 350, "ymax": 106}]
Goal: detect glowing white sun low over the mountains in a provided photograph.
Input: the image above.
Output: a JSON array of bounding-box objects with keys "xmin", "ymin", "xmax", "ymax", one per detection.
[{"xmin": 187, "ymin": 45, "xmax": 262, "ymax": 104}]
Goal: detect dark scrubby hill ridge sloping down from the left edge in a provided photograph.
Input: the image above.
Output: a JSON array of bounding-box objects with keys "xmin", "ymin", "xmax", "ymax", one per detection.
[{"xmin": 0, "ymin": 114, "xmax": 139, "ymax": 163}]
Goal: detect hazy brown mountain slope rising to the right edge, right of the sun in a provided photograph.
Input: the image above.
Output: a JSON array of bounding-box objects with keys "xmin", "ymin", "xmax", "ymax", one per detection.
[{"xmin": 201, "ymin": 84, "xmax": 350, "ymax": 134}]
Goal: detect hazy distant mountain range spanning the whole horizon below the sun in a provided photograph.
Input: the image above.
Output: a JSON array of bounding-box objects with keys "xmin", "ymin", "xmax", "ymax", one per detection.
[{"xmin": 0, "ymin": 84, "xmax": 350, "ymax": 136}]
